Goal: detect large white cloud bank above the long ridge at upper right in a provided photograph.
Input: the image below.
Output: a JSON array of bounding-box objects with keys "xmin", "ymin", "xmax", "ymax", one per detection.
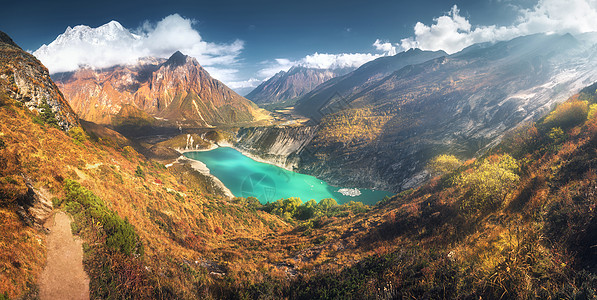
[{"xmin": 396, "ymin": 0, "xmax": 597, "ymax": 53}]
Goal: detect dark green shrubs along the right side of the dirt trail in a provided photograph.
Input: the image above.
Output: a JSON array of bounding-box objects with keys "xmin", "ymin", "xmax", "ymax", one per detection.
[{"xmin": 55, "ymin": 179, "xmax": 149, "ymax": 299}]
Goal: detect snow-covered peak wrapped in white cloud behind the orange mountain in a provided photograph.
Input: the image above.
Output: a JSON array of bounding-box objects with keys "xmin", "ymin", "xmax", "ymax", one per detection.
[{"xmin": 33, "ymin": 14, "xmax": 243, "ymax": 73}]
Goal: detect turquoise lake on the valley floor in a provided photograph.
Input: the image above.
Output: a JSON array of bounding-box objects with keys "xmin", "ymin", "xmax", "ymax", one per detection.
[{"xmin": 184, "ymin": 147, "xmax": 393, "ymax": 205}]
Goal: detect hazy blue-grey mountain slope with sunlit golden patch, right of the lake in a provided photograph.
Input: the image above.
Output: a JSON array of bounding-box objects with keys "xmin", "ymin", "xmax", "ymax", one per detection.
[{"xmin": 296, "ymin": 34, "xmax": 597, "ymax": 191}]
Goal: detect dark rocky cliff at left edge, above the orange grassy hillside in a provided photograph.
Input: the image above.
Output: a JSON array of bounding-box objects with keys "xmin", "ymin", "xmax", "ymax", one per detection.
[{"xmin": 0, "ymin": 32, "xmax": 79, "ymax": 131}]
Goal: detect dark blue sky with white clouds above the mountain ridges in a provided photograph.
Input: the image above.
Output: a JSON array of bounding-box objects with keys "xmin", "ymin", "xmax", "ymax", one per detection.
[{"xmin": 0, "ymin": 0, "xmax": 597, "ymax": 94}]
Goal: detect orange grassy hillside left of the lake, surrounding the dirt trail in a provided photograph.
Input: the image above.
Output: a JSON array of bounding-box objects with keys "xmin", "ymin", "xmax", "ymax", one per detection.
[{"xmin": 0, "ymin": 90, "xmax": 288, "ymax": 298}]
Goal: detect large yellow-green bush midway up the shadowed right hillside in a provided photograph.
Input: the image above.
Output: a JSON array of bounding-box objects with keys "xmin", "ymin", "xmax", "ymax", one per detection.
[{"xmin": 456, "ymin": 154, "xmax": 520, "ymax": 212}]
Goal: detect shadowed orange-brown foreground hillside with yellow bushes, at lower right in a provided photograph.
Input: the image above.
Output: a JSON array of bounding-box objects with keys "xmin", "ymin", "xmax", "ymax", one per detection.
[{"xmin": 278, "ymin": 84, "xmax": 597, "ymax": 299}]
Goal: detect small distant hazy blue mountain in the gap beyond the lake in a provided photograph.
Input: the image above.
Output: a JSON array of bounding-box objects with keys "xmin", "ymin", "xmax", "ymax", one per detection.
[{"xmin": 246, "ymin": 66, "xmax": 350, "ymax": 104}]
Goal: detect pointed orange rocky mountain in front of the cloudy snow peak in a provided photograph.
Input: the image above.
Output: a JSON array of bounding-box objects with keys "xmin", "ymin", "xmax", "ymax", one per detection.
[{"xmin": 54, "ymin": 52, "xmax": 267, "ymax": 127}]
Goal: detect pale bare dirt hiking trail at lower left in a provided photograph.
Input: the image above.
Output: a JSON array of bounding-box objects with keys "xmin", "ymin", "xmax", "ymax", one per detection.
[{"xmin": 39, "ymin": 212, "xmax": 89, "ymax": 300}]
